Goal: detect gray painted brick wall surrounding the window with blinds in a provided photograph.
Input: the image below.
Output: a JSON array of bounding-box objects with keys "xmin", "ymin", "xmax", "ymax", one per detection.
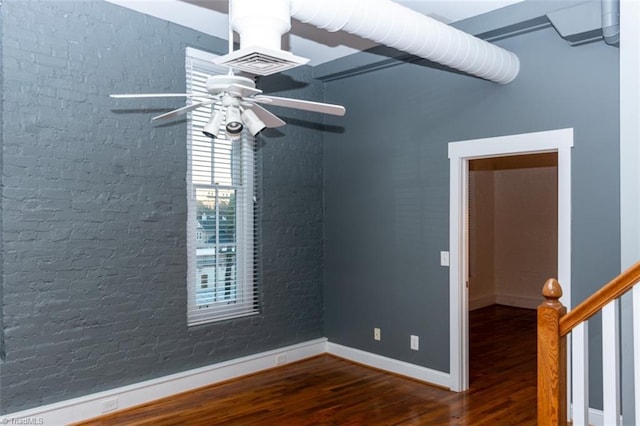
[{"xmin": 0, "ymin": 0, "xmax": 323, "ymax": 413}]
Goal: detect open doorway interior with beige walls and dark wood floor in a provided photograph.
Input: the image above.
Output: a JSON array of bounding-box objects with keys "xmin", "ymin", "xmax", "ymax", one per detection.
[{"xmin": 468, "ymin": 152, "xmax": 558, "ymax": 389}]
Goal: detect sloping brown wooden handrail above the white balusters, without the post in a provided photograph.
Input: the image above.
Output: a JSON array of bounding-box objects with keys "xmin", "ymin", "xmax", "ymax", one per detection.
[{"xmin": 560, "ymin": 262, "xmax": 640, "ymax": 336}]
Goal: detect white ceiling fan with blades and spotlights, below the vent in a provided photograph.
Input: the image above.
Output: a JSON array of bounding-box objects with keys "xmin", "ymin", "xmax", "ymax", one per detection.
[{"xmin": 110, "ymin": 74, "xmax": 345, "ymax": 139}]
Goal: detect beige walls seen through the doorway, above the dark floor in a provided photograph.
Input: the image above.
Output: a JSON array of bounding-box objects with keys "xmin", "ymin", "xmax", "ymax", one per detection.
[{"xmin": 468, "ymin": 152, "xmax": 558, "ymax": 311}]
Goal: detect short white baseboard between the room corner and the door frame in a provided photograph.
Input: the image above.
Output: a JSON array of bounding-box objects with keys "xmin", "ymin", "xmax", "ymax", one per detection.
[{"xmin": 327, "ymin": 342, "xmax": 451, "ymax": 388}]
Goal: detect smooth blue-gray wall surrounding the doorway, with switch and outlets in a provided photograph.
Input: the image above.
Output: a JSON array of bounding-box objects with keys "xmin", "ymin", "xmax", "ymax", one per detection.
[{"xmin": 325, "ymin": 22, "xmax": 620, "ymax": 399}]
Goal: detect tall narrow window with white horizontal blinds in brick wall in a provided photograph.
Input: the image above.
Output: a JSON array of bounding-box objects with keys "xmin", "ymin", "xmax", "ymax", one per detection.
[{"xmin": 186, "ymin": 48, "xmax": 258, "ymax": 325}]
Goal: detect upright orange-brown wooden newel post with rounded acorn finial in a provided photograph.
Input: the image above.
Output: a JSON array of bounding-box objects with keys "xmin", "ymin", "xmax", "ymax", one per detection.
[{"xmin": 538, "ymin": 279, "xmax": 567, "ymax": 426}]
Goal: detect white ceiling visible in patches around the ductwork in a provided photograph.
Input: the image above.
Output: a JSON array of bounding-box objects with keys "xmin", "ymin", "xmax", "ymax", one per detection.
[{"xmin": 107, "ymin": 0, "xmax": 523, "ymax": 65}]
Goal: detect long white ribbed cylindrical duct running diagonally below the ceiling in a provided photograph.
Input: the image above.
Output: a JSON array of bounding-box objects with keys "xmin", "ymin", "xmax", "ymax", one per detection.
[{"xmin": 290, "ymin": 0, "xmax": 520, "ymax": 84}]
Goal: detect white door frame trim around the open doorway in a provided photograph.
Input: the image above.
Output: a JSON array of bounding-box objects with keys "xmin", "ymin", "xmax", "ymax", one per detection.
[{"xmin": 449, "ymin": 129, "xmax": 573, "ymax": 392}]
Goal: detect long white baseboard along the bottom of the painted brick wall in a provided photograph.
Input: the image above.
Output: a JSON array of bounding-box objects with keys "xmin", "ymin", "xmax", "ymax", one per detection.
[{"xmin": 0, "ymin": 338, "xmax": 327, "ymax": 426}]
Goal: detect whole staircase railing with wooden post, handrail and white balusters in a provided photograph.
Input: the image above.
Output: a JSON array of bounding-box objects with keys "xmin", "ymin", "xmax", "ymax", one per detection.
[{"xmin": 538, "ymin": 262, "xmax": 640, "ymax": 426}]
